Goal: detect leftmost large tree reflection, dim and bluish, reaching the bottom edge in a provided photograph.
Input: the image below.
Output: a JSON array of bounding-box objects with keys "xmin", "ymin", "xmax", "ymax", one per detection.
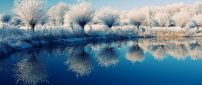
[{"xmin": 14, "ymin": 53, "xmax": 48, "ymax": 85}]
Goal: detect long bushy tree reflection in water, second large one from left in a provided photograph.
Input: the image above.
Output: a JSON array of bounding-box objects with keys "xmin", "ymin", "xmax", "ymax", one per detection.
[{"xmin": 65, "ymin": 46, "xmax": 92, "ymax": 77}]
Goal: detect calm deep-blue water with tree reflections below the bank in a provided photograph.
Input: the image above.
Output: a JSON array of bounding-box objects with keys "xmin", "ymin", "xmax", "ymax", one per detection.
[{"xmin": 0, "ymin": 38, "xmax": 202, "ymax": 85}]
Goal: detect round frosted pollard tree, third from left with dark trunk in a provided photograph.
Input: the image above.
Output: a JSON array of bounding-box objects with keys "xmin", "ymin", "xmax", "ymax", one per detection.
[{"xmin": 96, "ymin": 7, "xmax": 119, "ymax": 28}]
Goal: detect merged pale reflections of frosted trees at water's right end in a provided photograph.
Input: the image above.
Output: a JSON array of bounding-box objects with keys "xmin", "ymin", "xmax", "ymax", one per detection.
[{"xmin": 139, "ymin": 38, "xmax": 202, "ymax": 60}]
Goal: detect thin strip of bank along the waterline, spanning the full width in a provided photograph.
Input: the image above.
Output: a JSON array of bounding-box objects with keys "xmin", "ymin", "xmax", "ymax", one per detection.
[{"xmin": 0, "ymin": 36, "xmax": 200, "ymax": 56}]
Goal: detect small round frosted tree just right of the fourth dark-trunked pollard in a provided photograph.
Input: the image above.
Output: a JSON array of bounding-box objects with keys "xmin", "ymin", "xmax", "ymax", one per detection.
[{"xmin": 154, "ymin": 11, "xmax": 170, "ymax": 27}]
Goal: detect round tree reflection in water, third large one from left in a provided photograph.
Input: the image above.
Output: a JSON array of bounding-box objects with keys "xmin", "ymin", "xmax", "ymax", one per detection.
[{"xmin": 96, "ymin": 46, "xmax": 119, "ymax": 67}]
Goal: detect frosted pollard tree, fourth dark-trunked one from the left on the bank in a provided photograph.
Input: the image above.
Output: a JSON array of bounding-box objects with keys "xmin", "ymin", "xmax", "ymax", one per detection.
[{"xmin": 127, "ymin": 10, "xmax": 147, "ymax": 28}]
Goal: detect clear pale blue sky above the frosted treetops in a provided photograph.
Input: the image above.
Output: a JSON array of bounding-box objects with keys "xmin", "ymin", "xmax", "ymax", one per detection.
[{"xmin": 0, "ymin": 0, "xmax": 199, "ymax": 13}]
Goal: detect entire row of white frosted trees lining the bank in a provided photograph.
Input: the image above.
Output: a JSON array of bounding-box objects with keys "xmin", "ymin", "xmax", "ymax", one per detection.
[{"xmin": 1, "ymin": 0, "xmax": 202, "ymax": 31}]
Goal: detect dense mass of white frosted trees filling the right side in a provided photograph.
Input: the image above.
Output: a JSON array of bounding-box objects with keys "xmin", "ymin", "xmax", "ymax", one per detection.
[{"xmin": 127, "ymin": 2, "xmax": 202, "ymax": 28}]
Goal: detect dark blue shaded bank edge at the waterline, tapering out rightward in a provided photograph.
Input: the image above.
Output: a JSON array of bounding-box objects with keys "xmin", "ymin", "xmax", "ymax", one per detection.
[{"xmin": 0, "ymin": 36, "xmax": 138, "ymax": 55}]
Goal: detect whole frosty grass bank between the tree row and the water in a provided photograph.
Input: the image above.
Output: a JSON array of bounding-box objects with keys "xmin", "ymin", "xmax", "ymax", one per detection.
[{"xmin": 0, "ymin": 25, "xmax": 202, "ymax": 55}]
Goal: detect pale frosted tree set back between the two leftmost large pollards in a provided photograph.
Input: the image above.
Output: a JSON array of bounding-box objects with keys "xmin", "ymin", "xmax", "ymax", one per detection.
[{"xmin": 48, "ymin": 2, "xmax": 69, "ymax": 25}]
